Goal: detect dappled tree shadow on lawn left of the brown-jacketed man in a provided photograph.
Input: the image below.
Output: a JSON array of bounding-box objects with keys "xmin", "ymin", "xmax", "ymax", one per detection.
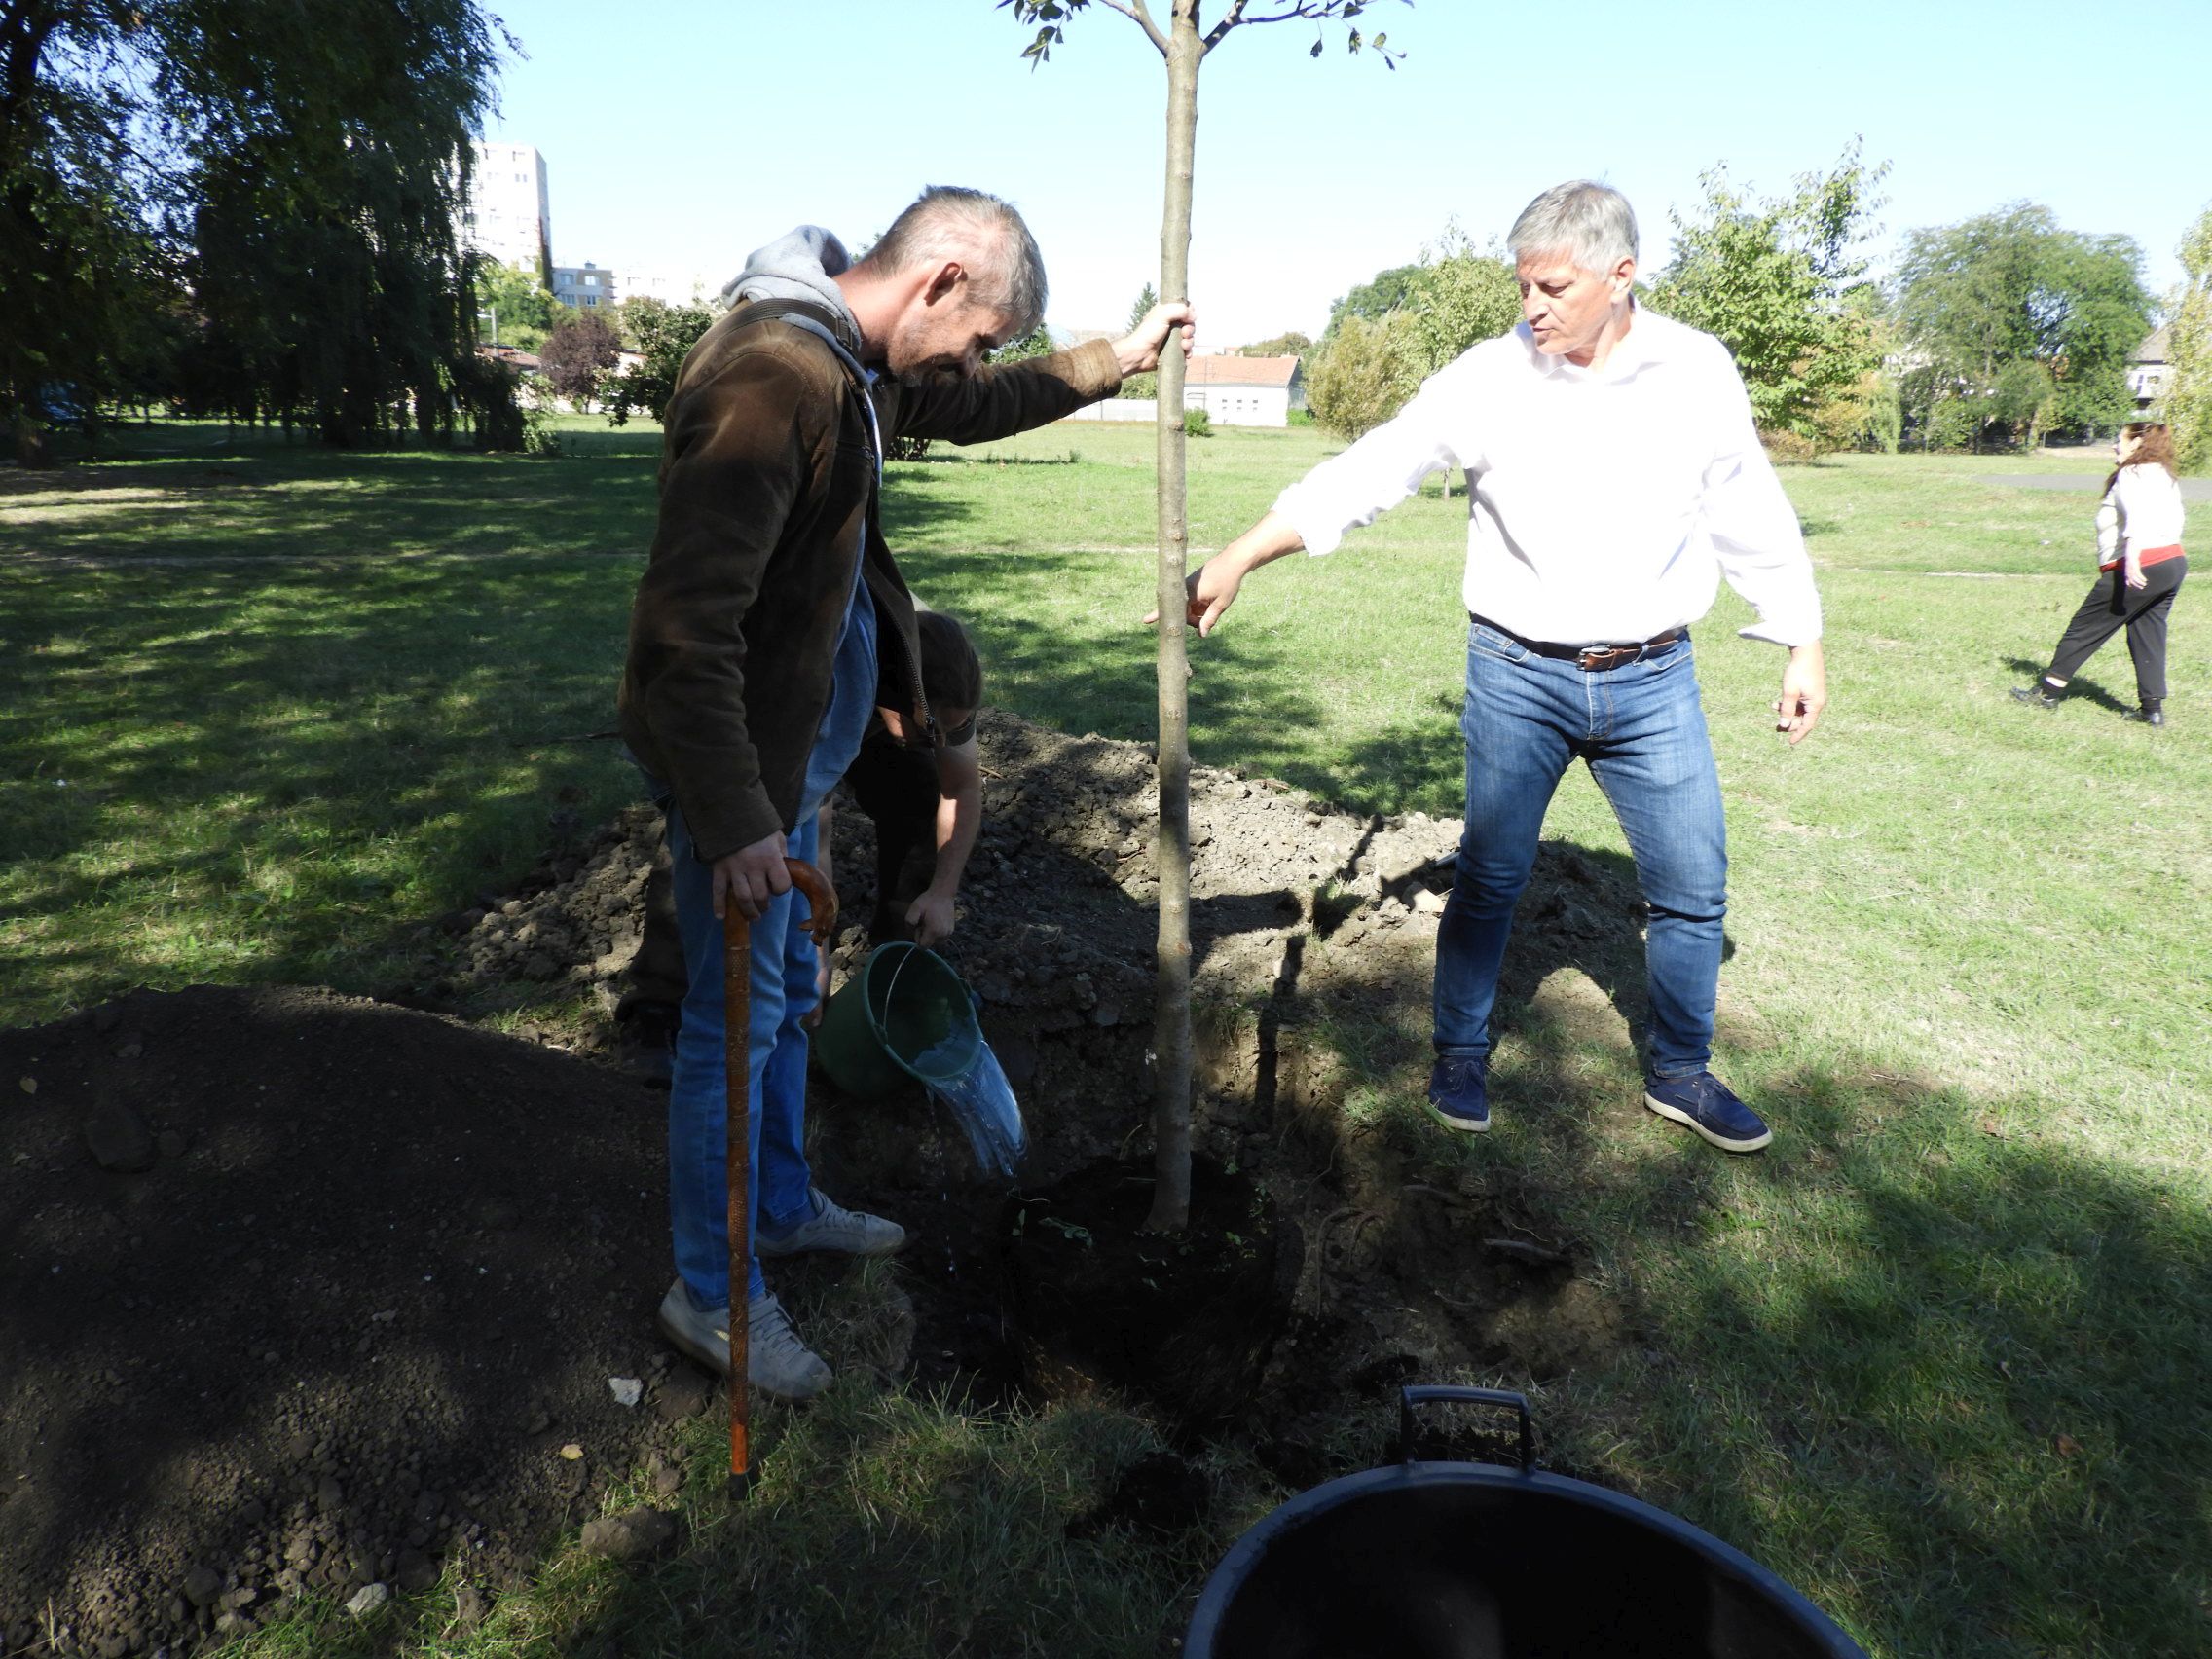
[{"xmin": 0, "ymin": 451, "xmax": 990, "ymax": 1017}]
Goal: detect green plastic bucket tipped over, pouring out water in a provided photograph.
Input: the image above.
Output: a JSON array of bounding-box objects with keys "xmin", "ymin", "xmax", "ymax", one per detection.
[{"xmin": 814, "ymin": 942, "xmax": 982, "ymax": 1099}]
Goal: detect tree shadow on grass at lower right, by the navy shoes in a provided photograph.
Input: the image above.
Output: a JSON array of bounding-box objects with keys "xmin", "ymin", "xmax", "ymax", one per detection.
[{"xmin": 1247, "ymin": 924, "xmax": 2212, "ymax": 1659}]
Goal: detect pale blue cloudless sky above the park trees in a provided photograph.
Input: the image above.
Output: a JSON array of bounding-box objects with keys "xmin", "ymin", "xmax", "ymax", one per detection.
[{"xmin": 487, "ymin": 0, "xmax": 2212, "ymax": 345}]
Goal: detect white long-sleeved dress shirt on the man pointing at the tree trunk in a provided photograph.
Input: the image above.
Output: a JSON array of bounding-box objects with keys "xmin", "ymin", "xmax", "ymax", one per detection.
[{"xmin": 1274, "ymin": 306, "xmax": 1821, "ymax": 645}]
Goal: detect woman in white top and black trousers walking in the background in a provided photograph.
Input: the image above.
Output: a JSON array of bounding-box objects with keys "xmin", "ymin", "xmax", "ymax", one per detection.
[{"xmin": 2013, "ymin": 421, "xmax": 2190, "ymax": 725}]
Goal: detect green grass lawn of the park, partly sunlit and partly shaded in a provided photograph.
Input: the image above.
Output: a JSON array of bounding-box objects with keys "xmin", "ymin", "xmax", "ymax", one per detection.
[{"xmin": 0, "ymin": 423, "xmax": 2212, "ymax": 1659}]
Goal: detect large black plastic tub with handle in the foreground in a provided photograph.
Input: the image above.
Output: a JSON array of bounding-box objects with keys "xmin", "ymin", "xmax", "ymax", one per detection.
[{"xmin": 1184, "ymin": 1387, "xmax": 1864, "ymax": 1659}]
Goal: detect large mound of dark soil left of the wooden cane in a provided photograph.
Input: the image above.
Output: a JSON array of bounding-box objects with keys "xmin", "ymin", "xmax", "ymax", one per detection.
[{"xmin": 0, "ymin": 989, "xmax": 701, "ymax": 1654}]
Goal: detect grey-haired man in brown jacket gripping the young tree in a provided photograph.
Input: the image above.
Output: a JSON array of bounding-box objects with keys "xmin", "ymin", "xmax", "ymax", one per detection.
[{"xmin": 619, "ymin": 188, "xmax": 1190, "ymax": 1398}]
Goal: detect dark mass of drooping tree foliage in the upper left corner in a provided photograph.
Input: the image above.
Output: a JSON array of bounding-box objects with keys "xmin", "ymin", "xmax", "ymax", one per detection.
[{"xmin": 0, "ymin": 0, "xmax": 496, "ymax": 456}]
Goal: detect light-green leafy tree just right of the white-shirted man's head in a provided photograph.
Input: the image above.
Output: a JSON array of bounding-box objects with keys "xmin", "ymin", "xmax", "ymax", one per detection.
[{"xmin": 1650, "ymin": 139, "xmax": 1889, "ymax": 438}]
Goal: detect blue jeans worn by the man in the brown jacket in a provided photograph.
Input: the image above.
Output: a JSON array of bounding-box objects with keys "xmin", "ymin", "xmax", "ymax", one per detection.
[{"xmin": 668, "ymin": 805, "xmax": 816, "ymax": 1308}]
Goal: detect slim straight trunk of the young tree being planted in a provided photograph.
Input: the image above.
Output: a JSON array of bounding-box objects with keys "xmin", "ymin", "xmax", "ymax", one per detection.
[{"xmin": 1146, "ymin": 0, "xmax": 1205, "ymax": 1233}]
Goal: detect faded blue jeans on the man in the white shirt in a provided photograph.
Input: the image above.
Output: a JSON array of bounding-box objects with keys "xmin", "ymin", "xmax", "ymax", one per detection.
[{"xmin": 1436, "ymin": 624, "xmax": 1727, "ymax": 1077}]
